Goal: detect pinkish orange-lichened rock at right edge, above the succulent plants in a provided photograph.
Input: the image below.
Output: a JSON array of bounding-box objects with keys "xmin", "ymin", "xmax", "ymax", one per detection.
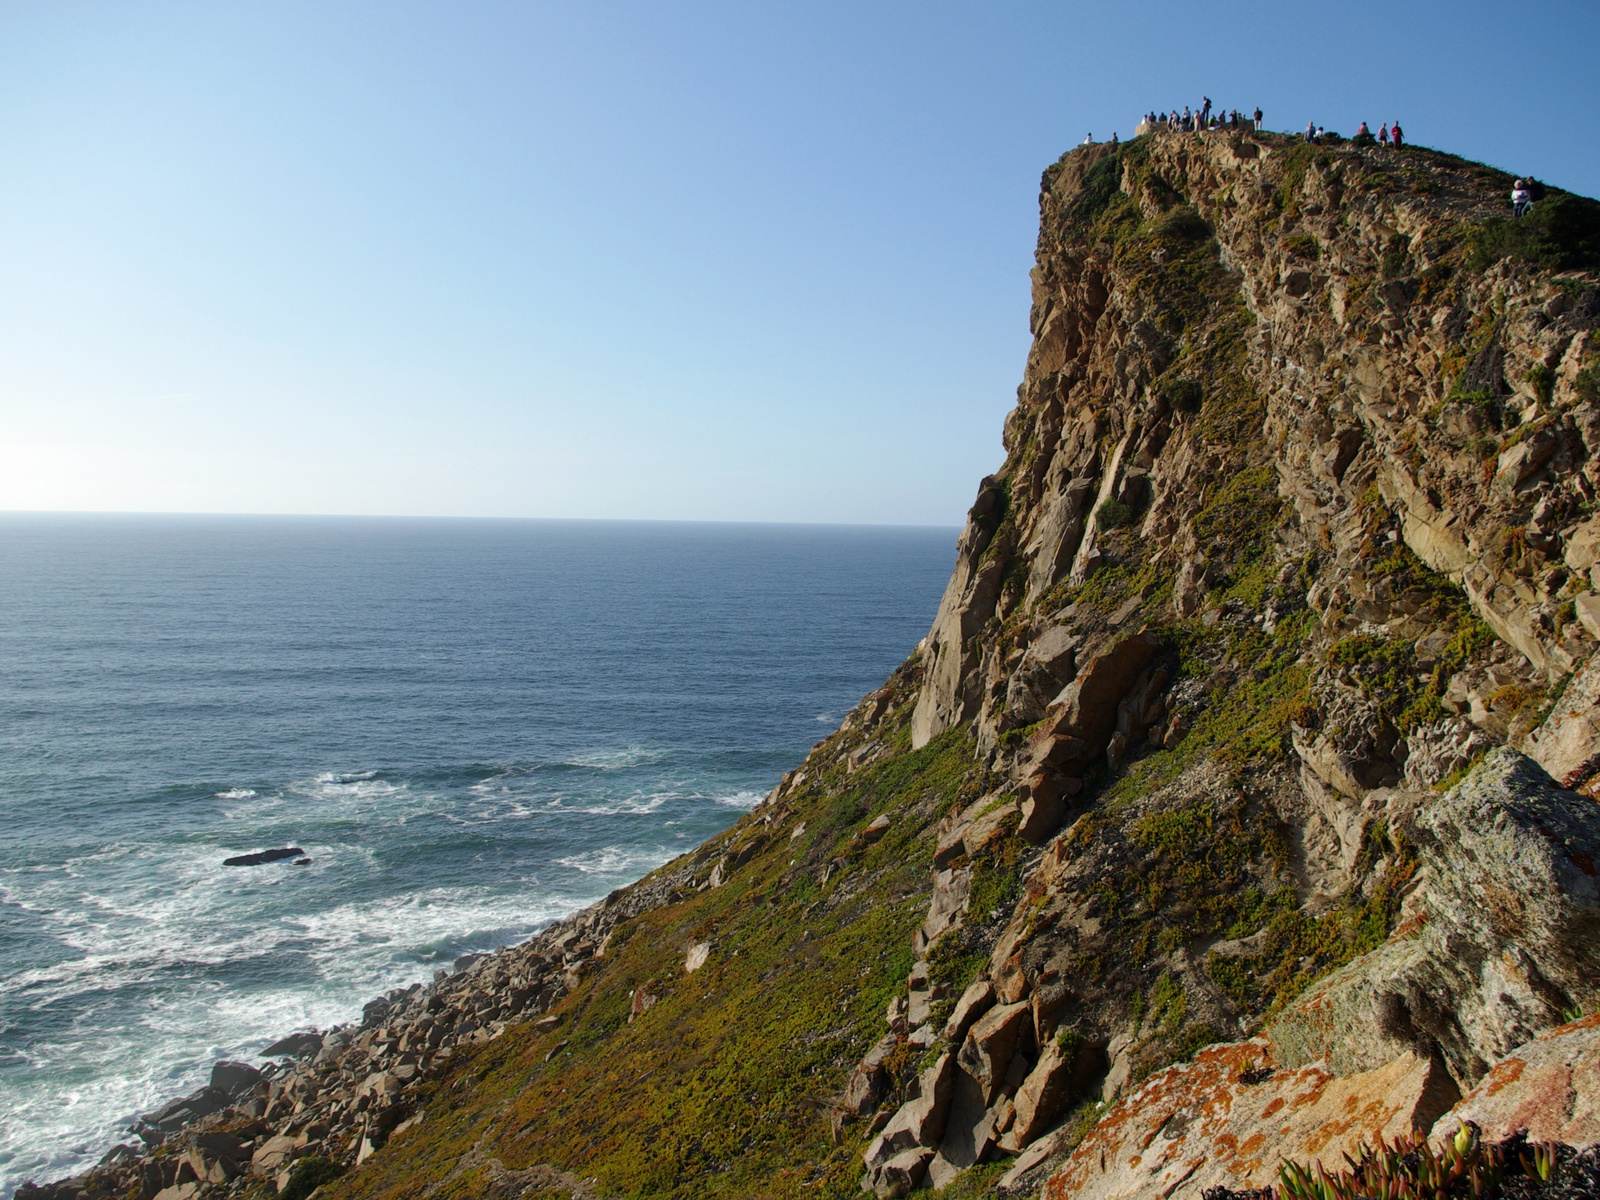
[{"xmin": 1434, "ymin": 1013, "xmax": 1600, "ymax": 1146}]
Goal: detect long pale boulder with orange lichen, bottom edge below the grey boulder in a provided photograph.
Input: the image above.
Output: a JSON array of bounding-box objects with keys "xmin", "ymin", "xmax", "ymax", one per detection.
[{"xmin": 1042, "ymin": 1038, "xmax": 1458, "ymax": 1200}]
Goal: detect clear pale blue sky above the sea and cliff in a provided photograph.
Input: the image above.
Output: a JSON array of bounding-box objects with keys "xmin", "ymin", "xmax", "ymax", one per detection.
[{"xmin": 0, "ymin": 0, "xmax": 1600, "ymax": 523}]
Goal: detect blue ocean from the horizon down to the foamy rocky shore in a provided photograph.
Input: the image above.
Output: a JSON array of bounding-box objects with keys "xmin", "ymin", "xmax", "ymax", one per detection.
[{"xmin": 0, "ymin": 515, "xmax": 955, "ymax": 1195}]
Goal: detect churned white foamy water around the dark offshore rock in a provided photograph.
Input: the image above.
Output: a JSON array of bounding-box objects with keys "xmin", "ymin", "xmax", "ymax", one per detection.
[{"xmin": 0, "ymin": 747, "xmax": 758, "ymax": 1195}]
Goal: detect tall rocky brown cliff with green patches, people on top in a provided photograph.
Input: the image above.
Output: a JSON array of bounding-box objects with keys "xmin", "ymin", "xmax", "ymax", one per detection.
[{"xmin": 21, "ymin": 131, "xmax": 1600, "ymax": 1200}]
